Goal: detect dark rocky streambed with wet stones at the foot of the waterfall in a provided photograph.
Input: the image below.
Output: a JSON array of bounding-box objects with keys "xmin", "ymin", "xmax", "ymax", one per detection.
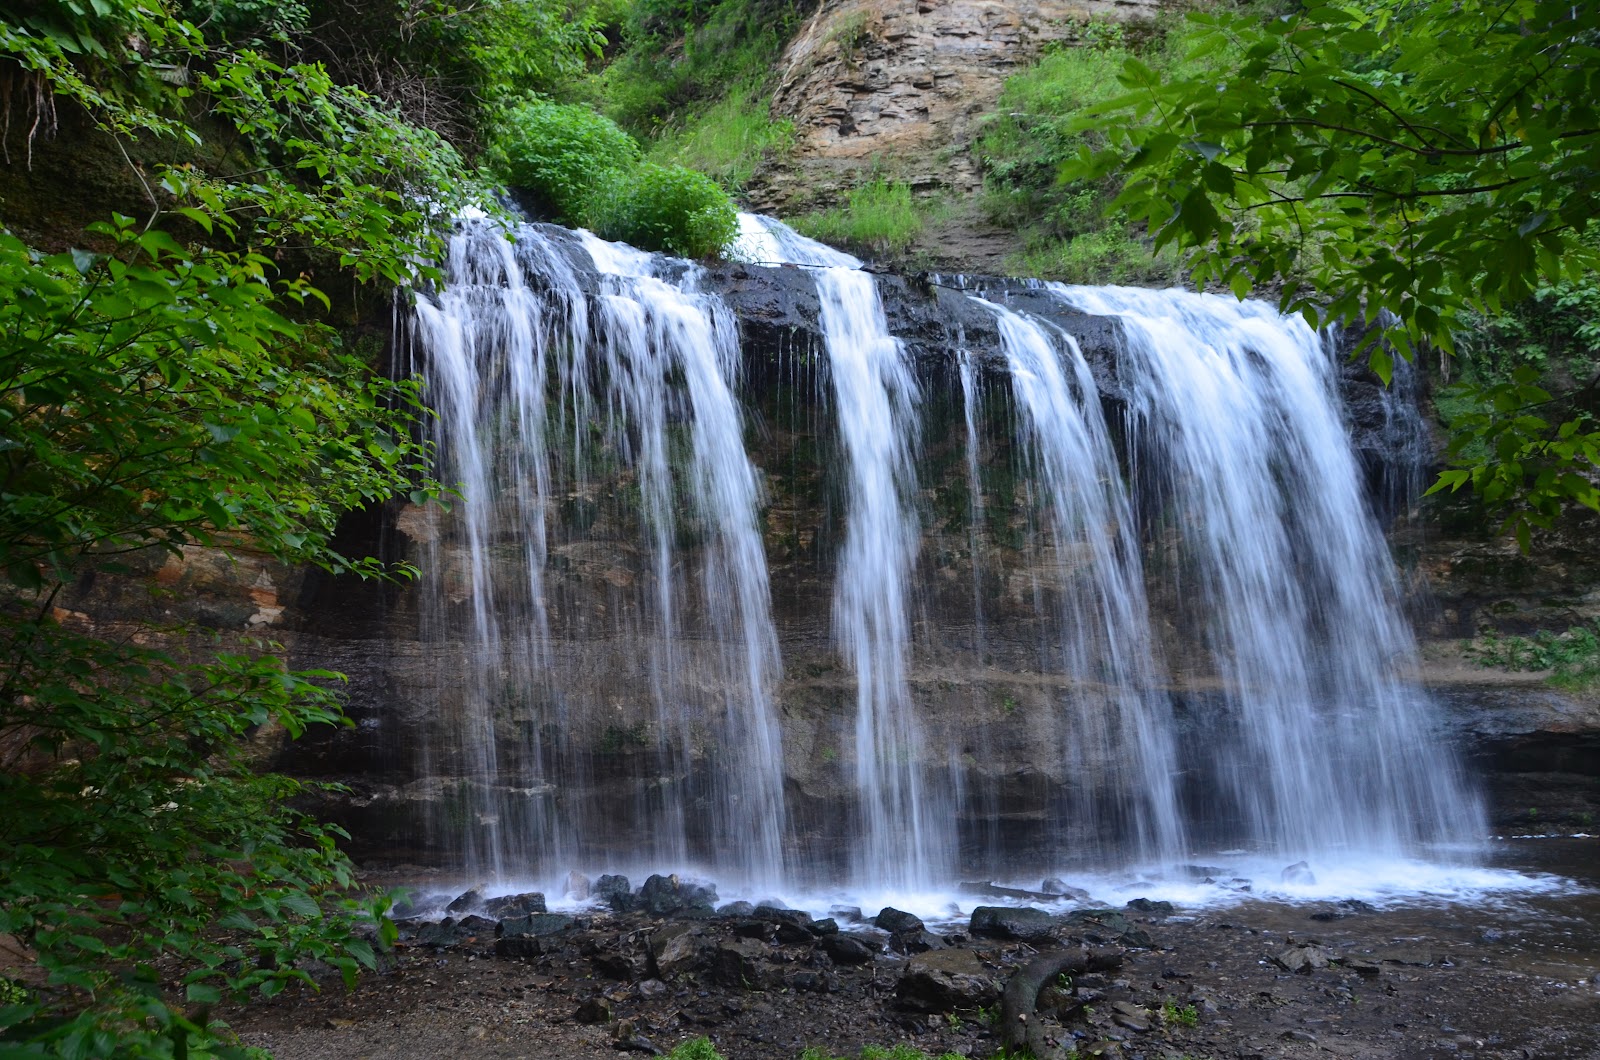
[{"xmin": 229, "ymin": 839, "xmax": 1600, "ymax": 1060}]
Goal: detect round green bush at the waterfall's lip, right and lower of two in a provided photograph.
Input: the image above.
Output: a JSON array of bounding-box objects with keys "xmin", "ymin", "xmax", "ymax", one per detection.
[{"xmin": 590, "ymin": 162, "xmax": 739, "ymax": 258}]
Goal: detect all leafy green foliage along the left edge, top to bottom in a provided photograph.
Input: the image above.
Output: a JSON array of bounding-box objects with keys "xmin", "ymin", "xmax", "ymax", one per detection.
[{"xmin": 0, "ymin": 0, "xmax": 478, "ymax": 1057}]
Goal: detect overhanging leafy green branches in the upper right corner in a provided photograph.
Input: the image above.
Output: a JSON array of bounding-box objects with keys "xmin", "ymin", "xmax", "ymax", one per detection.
[{"xmin": 1064, "ymin": 0, "xmax": 1600, "ymax": 548}]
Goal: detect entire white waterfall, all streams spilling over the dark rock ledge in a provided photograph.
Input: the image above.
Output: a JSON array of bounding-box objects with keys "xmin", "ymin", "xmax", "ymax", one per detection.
[{"xmin": 398, "ymin": 215, "xmax": 1482, "ymax": 897}]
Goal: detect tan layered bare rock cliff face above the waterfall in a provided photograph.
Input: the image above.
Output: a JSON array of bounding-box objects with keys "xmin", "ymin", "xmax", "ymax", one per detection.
[{"xmin": 749, "ymin": 0, "xmax": 1162, "ymax": 213}]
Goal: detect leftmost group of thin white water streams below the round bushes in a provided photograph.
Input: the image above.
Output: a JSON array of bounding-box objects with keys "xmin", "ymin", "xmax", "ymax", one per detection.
[{"xmin": 406, "ymin": 214, "xmax": 784, "ymax": 887}]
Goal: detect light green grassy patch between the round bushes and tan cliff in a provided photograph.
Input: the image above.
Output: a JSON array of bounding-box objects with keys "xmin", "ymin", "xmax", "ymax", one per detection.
[{"xmin": 650, "ymin": 85, "xmax": 794, "ymax": 189}]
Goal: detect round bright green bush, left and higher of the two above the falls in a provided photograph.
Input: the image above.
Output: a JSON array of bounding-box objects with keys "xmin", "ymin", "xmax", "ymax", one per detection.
[{"xmin": 493, "ymin": 99, "xmax": 638, "ymax": 224}]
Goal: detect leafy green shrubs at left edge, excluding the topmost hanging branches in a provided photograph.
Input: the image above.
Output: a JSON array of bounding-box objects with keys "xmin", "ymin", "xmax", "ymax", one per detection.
[{"xmin": 0, "ymin": 208, "xmax": 426, "ymax": 1055}]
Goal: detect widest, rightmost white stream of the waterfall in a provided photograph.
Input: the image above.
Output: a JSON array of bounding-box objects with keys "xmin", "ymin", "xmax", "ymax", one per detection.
[{"xmin": 1051, "ymin": 287, "xmax": 1483, "ymax": 857}]
